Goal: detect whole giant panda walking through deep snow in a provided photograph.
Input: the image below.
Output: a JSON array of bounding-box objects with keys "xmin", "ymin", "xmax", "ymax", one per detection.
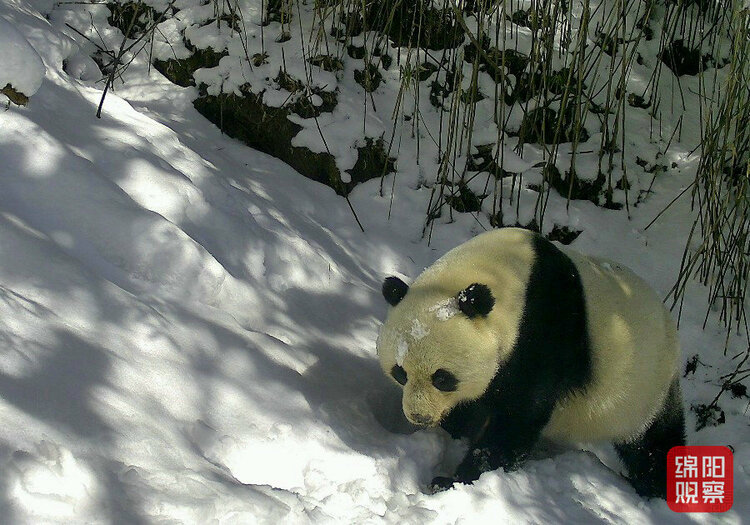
[{"xmin": 376, "ymin": 228, "xmax": 685, "ymax": 498}]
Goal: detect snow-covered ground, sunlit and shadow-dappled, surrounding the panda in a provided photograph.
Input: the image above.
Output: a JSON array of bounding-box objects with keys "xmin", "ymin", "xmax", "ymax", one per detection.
[{"xmin": 0, "ymin": 0, "xmax": 750, "ymax": 524}]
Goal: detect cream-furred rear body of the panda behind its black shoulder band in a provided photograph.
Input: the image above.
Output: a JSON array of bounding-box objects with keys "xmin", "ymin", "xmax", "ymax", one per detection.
[{"xmin": 545, "ymin": 249, "xmax": 680, "ymax": 441}]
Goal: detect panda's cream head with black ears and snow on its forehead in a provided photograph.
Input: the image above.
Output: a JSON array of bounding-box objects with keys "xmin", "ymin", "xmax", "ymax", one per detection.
[{"xmin": 377, "ymin": 277, "xmax": 502, "ymax": 426}]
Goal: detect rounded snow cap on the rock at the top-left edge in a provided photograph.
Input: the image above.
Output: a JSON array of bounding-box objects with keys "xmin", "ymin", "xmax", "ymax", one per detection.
[{"xmin": 0, "ymin": 17, "xmax": 45, "ymax": 97}]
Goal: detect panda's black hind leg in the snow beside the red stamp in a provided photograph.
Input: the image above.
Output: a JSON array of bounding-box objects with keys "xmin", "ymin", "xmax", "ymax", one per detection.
[{"xmin": 614, "ymin": 378, "xmax": 685, "ymax": 498}]
